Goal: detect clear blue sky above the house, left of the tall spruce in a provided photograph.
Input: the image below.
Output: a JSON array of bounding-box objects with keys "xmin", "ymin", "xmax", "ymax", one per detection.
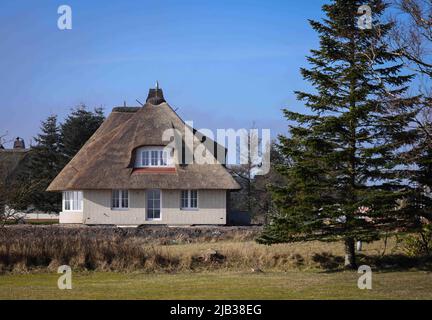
[{"xmin": 0, "ymin": 0, "xmax": 325, "ymax": 148}]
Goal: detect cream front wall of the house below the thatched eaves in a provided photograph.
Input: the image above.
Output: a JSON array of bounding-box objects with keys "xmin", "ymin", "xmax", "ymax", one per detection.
[{"xmin": 76, "ymin": 190, "xmax": 226, "ymax": 226}]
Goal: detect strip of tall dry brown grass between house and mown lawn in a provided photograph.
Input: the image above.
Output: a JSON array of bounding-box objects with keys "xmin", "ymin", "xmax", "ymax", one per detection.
[{"xmin": 0, "ymin": 226, "xmax": 430, "ymax": 273}]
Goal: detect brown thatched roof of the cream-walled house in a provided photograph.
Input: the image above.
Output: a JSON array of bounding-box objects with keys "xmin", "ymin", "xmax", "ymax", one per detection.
[{"xmin": 48, "ymin": 90, "xmax": 240, "ymax": 191}]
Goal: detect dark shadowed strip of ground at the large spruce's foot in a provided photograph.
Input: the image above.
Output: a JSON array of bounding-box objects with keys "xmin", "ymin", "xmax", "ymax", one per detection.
[{"xmin": 312, "ymin": 252, "xmax": 432, "ymax": 273}]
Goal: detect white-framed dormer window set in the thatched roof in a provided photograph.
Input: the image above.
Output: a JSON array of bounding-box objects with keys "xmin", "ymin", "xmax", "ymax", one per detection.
[{"xmin": 135, "ymin": 147, "xmax": 173, "ymax": 168}]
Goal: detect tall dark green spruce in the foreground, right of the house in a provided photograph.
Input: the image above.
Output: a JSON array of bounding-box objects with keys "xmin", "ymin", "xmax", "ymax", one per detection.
[{"xmin": 258, "ymin": 0, "xmax": 417, "ymax": 268}]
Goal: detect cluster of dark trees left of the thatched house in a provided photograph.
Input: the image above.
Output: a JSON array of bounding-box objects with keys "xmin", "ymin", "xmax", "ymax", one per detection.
[{"xmin": 0, "ymin": 105, "xmax": 105, "ymax": 215}]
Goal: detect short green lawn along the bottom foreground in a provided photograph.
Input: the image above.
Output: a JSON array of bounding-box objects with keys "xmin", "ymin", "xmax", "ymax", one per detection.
[{"xmin": 0, "ymin": 271, "xmax": 432, "ymax": 299}]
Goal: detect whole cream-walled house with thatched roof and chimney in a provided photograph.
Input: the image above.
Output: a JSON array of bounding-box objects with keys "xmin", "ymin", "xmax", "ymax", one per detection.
[{"xmin": 48, "ymin": 86, "xmax": 240, "ymax": 226}]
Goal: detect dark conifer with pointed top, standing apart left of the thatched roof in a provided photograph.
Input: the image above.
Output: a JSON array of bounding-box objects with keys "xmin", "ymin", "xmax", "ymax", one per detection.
[{"xmin": 25, "ymin": 115, "xmax": 62, "ymax": 212}]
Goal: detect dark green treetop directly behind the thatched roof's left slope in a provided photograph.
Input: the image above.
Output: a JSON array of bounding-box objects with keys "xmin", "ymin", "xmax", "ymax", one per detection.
[{"xmin": 61, "ymin": 105, "xmax": 105, "ymax": 165}]
